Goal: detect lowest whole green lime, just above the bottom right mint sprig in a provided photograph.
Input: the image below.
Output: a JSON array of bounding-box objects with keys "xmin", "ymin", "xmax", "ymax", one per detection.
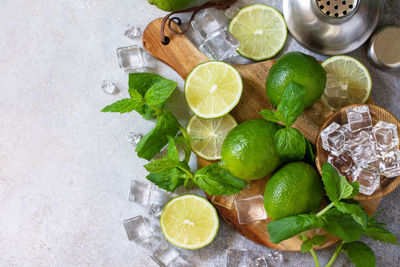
[{"xmin": 264, "ymin": 162, "xmax": 324, "ymax": 220}]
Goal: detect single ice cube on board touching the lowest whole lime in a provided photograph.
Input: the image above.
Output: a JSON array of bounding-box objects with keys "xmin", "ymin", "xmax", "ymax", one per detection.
[{"xmin": 235, "ymin": 195, "xmax": 267, "ymax": 224}]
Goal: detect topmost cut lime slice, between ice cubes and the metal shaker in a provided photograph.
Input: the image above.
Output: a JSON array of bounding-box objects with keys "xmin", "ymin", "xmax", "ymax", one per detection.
[{"xmin": 229, "ymin": 4, "xmax": 287, "ymax": 61}]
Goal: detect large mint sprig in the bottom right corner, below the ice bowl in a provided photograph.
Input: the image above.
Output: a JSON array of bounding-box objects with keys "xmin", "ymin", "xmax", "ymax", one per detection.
[{"xmin": 267, "ymin": 163, "xmax": 397, "ymax": 267}]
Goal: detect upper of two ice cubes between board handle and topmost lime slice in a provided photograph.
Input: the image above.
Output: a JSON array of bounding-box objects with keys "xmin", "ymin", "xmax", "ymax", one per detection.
[{"xmin": 192, "ymin": 9, "xmax": 228, "ymax": 40}]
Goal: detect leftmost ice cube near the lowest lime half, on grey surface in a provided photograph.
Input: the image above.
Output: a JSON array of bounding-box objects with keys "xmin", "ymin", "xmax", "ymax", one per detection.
[{"xmin": 123, "ymin": 215, "xmax": 152, "ymax": 248}]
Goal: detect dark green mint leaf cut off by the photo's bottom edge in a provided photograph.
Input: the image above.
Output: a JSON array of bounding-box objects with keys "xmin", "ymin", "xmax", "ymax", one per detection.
[{"xmin": 342, "ymin": 241, "xmax": 376, "ymax": 267}]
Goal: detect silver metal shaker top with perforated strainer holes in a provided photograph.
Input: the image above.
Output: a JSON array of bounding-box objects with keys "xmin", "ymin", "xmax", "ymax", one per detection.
[{"xmin": 283, "ymin": 0, "xmax": 380, "ymax": 55}]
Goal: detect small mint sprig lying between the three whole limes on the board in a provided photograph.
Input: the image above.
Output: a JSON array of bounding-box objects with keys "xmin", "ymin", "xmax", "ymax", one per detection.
[{"xmin": 260, "ymin": 82, "xmax": 313, "ymax": 162}]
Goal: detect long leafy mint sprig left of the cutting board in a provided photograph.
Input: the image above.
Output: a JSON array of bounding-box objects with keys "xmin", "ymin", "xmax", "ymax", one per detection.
[{"xmin": 102, "ymin": 73, "xmax": 247, "ymax": 195}]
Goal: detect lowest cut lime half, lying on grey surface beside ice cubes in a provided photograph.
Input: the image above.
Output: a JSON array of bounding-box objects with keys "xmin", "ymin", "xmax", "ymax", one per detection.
[{"xmin": 160, "ymin": 194, "xmax": 219, "ymax": 249}]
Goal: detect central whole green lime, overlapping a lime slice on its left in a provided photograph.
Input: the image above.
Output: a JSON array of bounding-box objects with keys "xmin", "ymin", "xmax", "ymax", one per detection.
[{"xmin": 220, "ymin": 119, "xmax": 281, "ymax": 180}]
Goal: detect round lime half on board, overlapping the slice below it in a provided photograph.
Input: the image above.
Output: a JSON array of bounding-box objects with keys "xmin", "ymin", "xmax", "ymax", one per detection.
[{"xmin": 185, "ymin": 61, "xmax": 243, "ymax": 118}]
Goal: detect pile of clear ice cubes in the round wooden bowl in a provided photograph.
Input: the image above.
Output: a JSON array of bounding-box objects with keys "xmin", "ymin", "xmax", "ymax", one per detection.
[{"xmin": 321, "ymin": 105, "xmax": 400, "ymax": 195}]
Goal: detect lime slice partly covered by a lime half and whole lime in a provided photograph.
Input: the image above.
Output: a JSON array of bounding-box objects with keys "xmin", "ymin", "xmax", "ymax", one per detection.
[{"xmin": 186, "ymin": 114, "xmax": 237, "ymax": 160}]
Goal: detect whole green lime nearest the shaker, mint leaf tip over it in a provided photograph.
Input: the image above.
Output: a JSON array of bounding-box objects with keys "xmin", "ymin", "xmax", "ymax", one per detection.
[{"xmin": 265, "ymin": 52, "xmax": 326, "ymax": 108}]
